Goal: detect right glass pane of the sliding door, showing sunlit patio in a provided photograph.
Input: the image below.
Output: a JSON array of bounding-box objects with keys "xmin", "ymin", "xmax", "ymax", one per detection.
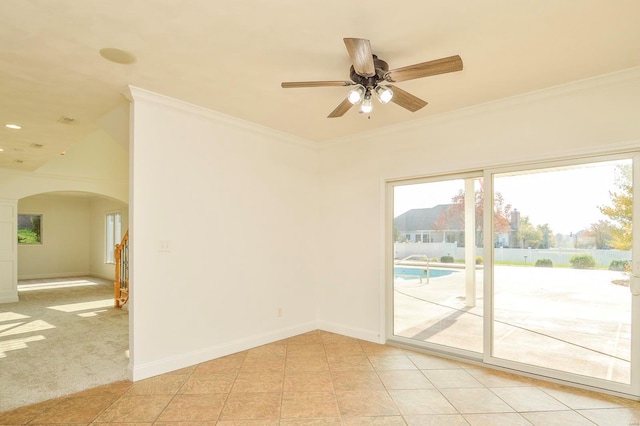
[{"xmin": 491, "ymin": 159, "xmax": 633, "ymax": 385}]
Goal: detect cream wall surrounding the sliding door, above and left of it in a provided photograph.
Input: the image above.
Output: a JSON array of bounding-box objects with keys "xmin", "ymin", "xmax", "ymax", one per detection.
[{"xmin": 317, "ymin": 69, "xmax": 640, "ymax": 339}]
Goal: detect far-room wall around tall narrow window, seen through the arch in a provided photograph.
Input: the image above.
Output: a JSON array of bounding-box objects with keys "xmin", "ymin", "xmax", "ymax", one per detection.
[{"xmin": 89, "ymin": 197, "xmax": 129, "ymax": 280}]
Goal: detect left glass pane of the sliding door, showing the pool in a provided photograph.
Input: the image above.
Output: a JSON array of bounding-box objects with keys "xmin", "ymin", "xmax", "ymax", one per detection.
[{"xmin": 392, "ymin": 177, "xmax": 483, "ymax": 353}]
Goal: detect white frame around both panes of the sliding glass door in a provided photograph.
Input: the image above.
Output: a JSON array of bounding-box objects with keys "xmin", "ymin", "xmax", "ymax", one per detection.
[{"xmin": 388, "ymin": 149, "xmax": 640, "ymax": 399}]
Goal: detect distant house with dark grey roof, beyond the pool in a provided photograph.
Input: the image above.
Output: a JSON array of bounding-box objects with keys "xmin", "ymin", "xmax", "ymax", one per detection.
[{"xmin": 393, "ymin": 204, "xmax": 464, "ymax": 246}]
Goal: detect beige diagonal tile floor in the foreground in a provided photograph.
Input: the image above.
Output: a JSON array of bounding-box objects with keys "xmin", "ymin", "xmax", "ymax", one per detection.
[{"xmin": 0, "ymin": 331, "xmax": 640, "ymax": 426}]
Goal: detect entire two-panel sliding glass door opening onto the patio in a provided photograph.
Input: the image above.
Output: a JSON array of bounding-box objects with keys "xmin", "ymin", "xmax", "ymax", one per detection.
[{"xmin": 387, "ymin": 154, "xmax": 640, "ymax": 396}]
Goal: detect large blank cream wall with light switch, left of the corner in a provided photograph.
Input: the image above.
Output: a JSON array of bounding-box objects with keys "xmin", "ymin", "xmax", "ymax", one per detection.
[{"xmin": 130, "ymin": 88, "xmax": 318, "ymax": 379}]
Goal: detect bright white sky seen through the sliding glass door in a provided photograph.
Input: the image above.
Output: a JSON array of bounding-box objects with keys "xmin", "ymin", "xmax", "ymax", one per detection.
[{"xmin": 394, "ymin": 160, "xmax": 630, "ymax": 235}]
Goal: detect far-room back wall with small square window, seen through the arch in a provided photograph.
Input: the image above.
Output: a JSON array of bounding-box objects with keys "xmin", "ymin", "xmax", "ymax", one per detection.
[{"xmin": 18, "ymin": 194, "xmax": 91, "ymax": 279}]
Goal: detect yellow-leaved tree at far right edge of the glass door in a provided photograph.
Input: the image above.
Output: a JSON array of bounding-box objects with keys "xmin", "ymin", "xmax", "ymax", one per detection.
[{"xmin": 598, "ymin": 164, "xmax": 633, "ymax": 250}]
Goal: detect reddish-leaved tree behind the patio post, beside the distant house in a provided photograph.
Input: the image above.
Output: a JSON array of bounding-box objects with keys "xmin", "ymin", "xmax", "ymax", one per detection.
[{"xmin": 434, "ymin": 180, "xmax": 511, "ymax": 247}]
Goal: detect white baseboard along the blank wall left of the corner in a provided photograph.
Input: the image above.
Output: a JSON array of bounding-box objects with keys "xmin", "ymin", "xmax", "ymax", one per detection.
[{"xmin": 129, "ymin": 321, "xmax": 318, "ymax": 382}]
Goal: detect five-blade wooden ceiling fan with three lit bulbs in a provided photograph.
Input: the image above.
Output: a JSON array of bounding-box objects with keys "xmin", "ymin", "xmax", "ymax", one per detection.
[{"xmin": 281, "ymin": 38, "xmax": 462, "ymax": 118}]
